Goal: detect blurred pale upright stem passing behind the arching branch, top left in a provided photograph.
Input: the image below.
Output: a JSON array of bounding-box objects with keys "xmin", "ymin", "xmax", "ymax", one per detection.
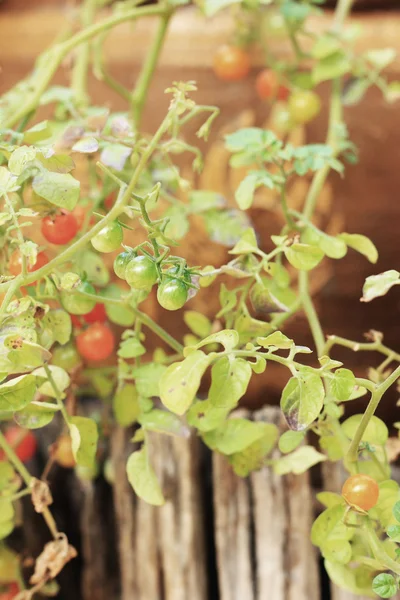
[{"xmin": 71, "ymin": 0, "xmax": 97, "ymax": 106}]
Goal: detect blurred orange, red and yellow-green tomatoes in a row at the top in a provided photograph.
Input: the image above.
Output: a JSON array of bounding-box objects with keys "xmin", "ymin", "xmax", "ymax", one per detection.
[{"xmin": 214, "ymin": 45, "xmax": 321, "ymax": 125}]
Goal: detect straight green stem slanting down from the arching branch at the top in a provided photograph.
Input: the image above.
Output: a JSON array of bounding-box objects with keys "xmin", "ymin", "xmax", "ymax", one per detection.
[{"xmin": 131, "ymin": 9, "xmax": 172, "ymax": 128}]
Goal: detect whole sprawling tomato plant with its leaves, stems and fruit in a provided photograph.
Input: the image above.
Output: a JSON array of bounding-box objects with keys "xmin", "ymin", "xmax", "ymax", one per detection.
[{"xmin": 0, "ymin": 0, "xmax": 400, "ymax": 598}]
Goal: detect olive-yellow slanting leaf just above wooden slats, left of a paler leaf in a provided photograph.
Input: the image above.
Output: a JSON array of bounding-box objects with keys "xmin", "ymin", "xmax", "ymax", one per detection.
[{"xmin": 229, "ymin": 423, "xmax": 279, "ymax": 477}]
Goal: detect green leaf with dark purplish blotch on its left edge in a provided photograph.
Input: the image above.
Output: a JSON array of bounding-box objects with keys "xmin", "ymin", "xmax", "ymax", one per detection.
[{"xmin": 281, "ymin": 369, "xmax": 325, "ymax": 431}]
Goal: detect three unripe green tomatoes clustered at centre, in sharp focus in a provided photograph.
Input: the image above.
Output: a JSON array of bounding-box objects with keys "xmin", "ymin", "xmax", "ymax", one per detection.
[{"xmin": 114, "ymin": 250, "xmax": 190, "ymax": 310}]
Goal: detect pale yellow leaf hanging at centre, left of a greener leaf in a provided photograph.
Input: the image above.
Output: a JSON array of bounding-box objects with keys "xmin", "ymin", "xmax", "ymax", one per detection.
[{"xmin": 160, "ymin": 350, "xmax": 212, "ymax": 415}]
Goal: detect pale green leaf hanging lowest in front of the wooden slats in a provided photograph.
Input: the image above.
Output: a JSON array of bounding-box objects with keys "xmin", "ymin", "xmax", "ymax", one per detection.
[{"xmin": 126, "ymin": 446, "xmax": 165, "ymax": 506}]
